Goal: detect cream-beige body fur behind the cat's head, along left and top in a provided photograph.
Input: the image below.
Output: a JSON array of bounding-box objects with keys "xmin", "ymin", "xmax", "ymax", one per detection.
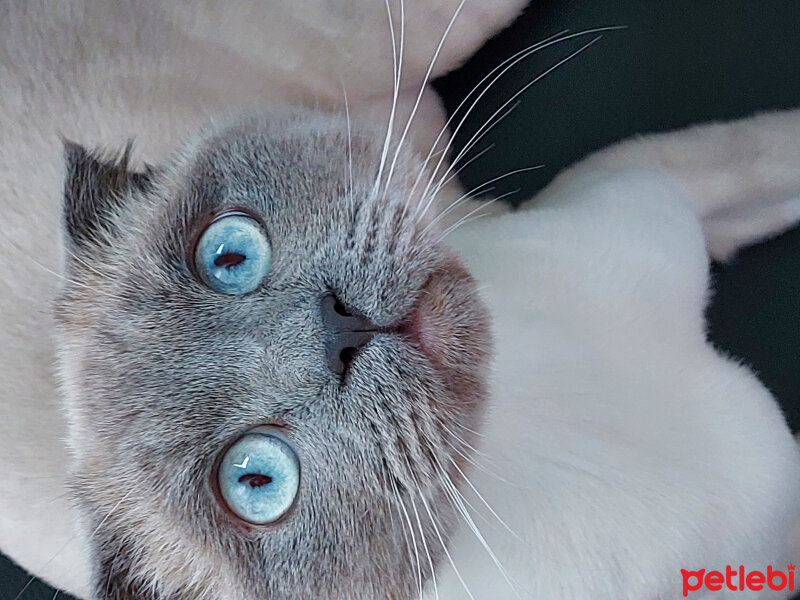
[{"xmin": 0, "ymin": 0, "xmax": 524, "ymax": 596}]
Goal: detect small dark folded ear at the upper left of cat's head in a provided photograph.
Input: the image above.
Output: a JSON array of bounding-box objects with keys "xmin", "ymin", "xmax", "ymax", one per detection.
[{"xmin": 63, "ymin": 140, "xmax": 153, "ymax": 247}]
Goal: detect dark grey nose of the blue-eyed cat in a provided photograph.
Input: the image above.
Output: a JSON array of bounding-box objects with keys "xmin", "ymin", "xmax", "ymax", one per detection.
[{"xmin": 319, "ymin": 294, "xmax": 380, "ymax": 375}]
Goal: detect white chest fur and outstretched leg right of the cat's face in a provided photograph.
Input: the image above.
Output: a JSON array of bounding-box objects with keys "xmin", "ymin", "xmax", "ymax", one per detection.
[{"xmin": 440, "ymin": 111, "xmax": 800, "ymax": 600}]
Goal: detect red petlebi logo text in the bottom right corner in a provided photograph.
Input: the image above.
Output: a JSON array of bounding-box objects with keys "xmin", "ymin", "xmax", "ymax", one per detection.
[{"xmin": 681, "ymin": 564, "xmax": 795, "ymax": 598}]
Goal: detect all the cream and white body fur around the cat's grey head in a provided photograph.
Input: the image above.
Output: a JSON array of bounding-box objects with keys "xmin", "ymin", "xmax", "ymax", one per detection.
[{"xmin": 0, "ymin": 0, "xmax": 800, "ymax": 600}]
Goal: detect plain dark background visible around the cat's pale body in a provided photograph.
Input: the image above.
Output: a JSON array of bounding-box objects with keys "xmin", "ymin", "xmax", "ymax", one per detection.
[{"xmin": 0, "ymin": 0, "xmax": 800, "ymax": 600}]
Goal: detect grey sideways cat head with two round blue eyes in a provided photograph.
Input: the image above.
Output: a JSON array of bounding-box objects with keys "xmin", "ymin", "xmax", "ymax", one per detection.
[{"xmin": 56, "ymin": 112, "xmax": 490, "ymax": 600}]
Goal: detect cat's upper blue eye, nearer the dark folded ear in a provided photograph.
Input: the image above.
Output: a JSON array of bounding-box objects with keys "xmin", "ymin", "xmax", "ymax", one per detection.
[{"xmin": 193, "ymin": 212, "xmax": 272, "ymax": 294}]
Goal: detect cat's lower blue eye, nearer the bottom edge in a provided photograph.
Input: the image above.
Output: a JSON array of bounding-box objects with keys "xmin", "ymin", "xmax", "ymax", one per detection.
[{"xmin": 217, "ymin": 431, "xmax": 300, "ymax": 525}]
